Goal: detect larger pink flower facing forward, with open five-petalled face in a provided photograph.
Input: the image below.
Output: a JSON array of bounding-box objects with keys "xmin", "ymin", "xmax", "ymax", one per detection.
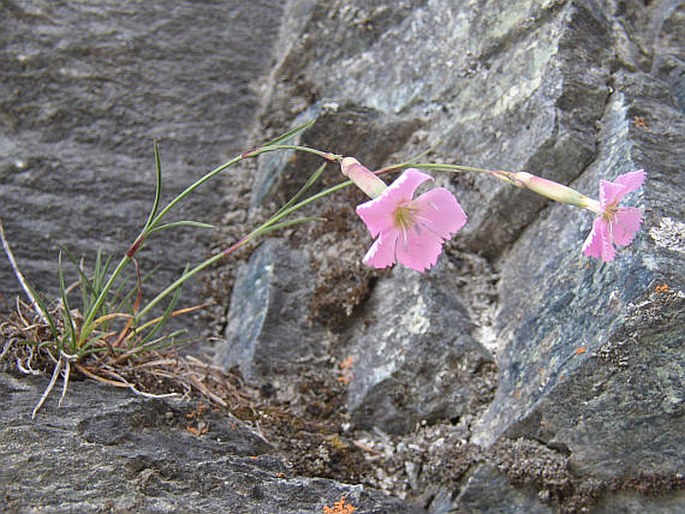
[{"xmin": 357, "ymin": 168, "xmax": 466, "ymax": 271}]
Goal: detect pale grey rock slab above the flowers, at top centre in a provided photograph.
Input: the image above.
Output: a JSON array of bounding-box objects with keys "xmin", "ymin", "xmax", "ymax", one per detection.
[{"xmin": 260, "ymin": 1, "xmax": 611, "ymax": 256}]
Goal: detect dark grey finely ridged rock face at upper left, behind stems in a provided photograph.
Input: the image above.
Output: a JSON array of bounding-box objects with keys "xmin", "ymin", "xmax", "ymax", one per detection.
[{"xmin": 0, "ymin": 0, "xmax": 280, "ymax": 312}]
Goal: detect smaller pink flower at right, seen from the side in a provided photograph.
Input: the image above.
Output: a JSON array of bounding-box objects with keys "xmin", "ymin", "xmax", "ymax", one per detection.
[{"xmin": 583, "ymin": 170, "xmax": 646, "ymax": 262}]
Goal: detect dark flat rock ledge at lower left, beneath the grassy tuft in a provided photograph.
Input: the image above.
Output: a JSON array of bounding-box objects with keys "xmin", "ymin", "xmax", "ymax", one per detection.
[{"xmin": 0, "ymin": 373, "xmax": 425, "ymax": 514}]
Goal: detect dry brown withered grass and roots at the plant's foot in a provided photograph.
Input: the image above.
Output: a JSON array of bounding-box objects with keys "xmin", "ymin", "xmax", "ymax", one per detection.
[{"xmin": 0, "ymin": 290, "xmax": 255, "ymax": 418}]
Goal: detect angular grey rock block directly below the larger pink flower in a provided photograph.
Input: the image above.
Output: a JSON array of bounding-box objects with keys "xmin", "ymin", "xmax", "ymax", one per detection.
[{"xmin": 347, "ymin": 263, "xmax": 496, "ymax": 434}]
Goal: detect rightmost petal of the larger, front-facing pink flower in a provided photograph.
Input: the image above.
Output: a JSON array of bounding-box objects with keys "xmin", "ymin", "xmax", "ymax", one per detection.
[{"xmin": 413, "ymin": 187, "xmax": 466, "ymax": 239}]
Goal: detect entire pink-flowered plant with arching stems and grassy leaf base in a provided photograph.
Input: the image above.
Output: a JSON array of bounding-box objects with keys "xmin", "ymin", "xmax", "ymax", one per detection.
[{"xmin": 0, "ymin": 121, "xmax": 646, "ymax": 415}]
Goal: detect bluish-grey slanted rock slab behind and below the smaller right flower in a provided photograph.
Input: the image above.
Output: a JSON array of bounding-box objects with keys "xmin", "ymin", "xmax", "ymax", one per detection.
[{"xmin": 473, "ymin": 37, "xmax": 685, "ymax": 512}]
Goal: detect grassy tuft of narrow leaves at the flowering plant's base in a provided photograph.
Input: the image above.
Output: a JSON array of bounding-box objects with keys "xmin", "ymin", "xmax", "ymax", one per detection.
[{"xmin": 0, "ymin": 231, "xmax": 211, "ymax": 417}]
